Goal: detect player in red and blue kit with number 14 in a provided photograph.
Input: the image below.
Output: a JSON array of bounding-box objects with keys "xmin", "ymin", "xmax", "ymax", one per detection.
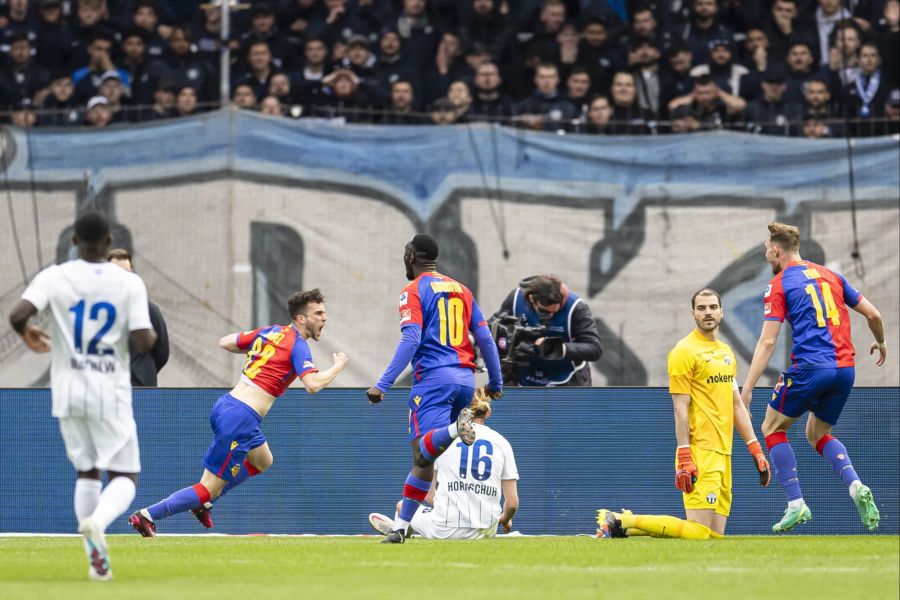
[{"xmin": 741, "ymin": 223, "xmax": 887, "ymax": 533}]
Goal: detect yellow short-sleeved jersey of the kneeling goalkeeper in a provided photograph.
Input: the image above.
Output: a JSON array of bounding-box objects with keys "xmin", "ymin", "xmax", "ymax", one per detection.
[{"xmin": 668, "ymin": 329, "xmax": 737, "ymax": 454}]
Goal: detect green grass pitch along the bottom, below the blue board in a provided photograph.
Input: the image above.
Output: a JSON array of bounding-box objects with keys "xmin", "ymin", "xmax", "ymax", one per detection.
[{"xmin": 0, "ymin": 535, "xmax": 900, "ymax": 600}]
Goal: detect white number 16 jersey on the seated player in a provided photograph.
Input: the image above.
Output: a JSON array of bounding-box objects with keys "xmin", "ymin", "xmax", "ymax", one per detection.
[{"xmin": 432, "ymin": 423, "xmax": 519, "ymax": 529}]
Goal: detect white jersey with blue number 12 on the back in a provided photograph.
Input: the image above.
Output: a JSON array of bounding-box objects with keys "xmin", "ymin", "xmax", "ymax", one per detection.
[{"xmin": 22, "ymin": 259, "xmax": 152, "ymax": 421}]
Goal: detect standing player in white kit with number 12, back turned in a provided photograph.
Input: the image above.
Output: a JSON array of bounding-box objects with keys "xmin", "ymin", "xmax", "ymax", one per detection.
[{"xmin": 9, "ymin": 212, "xmax": 156, "ymax": 581}]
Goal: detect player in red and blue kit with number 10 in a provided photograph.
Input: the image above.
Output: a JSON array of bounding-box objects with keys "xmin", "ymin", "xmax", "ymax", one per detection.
[{"xmin": 366, "ymin": 234, "xmax": 503, "ymax": 544}]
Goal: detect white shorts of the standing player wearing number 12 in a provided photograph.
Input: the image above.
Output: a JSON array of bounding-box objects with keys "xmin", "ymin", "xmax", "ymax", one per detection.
[{"xmin": 59, "ymin": 416, "xmax": 141, "ymax": 473}]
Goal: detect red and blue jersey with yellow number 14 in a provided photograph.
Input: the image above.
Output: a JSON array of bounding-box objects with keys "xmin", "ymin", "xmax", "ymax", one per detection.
[{"xmin": 763, "ymin": 260, "xmax": 862, "ymax": 368}]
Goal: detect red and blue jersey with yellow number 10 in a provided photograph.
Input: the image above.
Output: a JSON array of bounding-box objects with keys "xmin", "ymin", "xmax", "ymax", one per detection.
[{"xmin": 400, "ymin": 273, "xmax": 487, "ymax": 385}]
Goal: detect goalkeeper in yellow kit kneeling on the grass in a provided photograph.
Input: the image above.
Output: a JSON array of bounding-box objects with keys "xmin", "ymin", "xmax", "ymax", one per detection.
[{"xmin": 597, "ymin": 288, "xmax": 770, "ymax": 540}]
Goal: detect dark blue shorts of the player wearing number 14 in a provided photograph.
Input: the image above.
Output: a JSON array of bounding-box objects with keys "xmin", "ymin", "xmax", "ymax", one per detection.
[{"xmin": 769, "ymin": 367, "xmax": 856, "ymax": 425}]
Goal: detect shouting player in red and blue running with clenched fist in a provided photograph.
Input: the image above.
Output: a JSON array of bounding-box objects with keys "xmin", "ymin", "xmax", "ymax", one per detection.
[{"xmin": 128, "ymin": 289, "xmax": 347, "ymax": 537}]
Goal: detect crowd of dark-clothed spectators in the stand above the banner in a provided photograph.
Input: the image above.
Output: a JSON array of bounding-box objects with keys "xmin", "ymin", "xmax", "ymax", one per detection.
[{"xmin": 0, "ymin": 0, "xmax": 900, "ymax": 138}]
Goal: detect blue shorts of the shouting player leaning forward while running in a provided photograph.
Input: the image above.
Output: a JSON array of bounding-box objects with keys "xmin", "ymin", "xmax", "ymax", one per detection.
[{"xmin": 203, "ymin": 394, "xmax": 266, "ymax": 481}]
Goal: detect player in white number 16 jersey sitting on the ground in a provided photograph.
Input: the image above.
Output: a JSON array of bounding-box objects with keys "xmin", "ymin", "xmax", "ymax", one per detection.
[{"xmin": 369, "ymin": 388, "xmax": 519, "ymax": 540}]
